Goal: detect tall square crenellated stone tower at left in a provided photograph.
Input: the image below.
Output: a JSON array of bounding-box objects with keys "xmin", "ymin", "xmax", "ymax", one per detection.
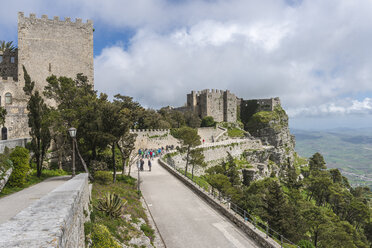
[{"xmin": 18, "ymin": 12, "xmax": 94, "ymax": 96}]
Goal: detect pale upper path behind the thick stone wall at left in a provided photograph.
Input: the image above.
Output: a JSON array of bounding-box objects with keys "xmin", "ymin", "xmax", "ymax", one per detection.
[{"xmin": 0, "ymin": 176, "xmax": 71, "ymax": 224}]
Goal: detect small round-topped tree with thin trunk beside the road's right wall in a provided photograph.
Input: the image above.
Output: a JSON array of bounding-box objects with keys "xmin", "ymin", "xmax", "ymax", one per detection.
[{"xmin": 173, "ymin": 127, "xmax": 201, "ymax": 176}]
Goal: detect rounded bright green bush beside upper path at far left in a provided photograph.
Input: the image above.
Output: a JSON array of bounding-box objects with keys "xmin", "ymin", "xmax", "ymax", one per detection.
[{"xmin": 8, "ymin": 146, "xmax": 30, "ymax": 187}]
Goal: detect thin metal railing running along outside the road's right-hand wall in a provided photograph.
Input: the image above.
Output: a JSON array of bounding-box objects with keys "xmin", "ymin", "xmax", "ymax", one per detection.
[{"xmin": 162, "ymin": 161, "xmax": 299, "ymax": 248}]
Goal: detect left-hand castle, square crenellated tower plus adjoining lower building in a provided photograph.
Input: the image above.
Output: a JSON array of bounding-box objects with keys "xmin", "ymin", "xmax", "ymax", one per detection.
[{"xmin": 0, "ymin": 12, "xmax": 94, "ymax": 139}]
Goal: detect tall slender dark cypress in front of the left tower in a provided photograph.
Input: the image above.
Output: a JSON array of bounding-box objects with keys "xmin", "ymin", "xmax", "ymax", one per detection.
[{"xmin": 23, "ymin": 66, "xmax": 51, "ymax": 177}]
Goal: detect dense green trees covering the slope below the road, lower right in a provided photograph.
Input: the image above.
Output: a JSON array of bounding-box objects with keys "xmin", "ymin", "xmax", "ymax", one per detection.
[{"xmin": 205, "ymin": 153, "xmax": 372, "ymax": 248}]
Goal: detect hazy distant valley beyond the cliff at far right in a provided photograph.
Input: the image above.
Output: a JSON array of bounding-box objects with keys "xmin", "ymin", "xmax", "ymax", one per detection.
[{"xmin": 291, "ymin": 128, "xmax": 372, "ymax": 188}]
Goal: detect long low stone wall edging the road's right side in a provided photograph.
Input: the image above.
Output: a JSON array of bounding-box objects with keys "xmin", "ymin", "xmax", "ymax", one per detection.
[{"xmin": 159, "ymin": 159, "xmax": 280, "ymax": 248}]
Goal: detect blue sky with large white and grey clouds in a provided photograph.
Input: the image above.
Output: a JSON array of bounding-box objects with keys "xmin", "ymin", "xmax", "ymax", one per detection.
[{"xmin": 0, "ymin": 0, "xmax": 372, "ymax": 129}]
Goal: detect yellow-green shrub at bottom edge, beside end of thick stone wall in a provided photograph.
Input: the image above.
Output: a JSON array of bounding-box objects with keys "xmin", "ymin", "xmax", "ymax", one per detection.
[{"xmin": 91, "ymin": 224, "xmax": 121, "ymax": 248}]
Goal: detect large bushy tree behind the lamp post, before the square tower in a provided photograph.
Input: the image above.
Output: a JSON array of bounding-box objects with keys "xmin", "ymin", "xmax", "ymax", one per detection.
[{"xmin": 44, "ymin": 74, "xmax": 100, "ymax": 165}]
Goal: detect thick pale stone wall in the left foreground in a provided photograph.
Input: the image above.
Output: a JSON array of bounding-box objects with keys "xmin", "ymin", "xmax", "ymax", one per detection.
[{"xmin": 0, "ymin": 173, "xmax": 90, "ymax": 248}]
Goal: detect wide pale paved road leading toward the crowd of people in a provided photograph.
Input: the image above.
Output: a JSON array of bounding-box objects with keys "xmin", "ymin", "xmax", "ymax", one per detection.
[{"xmin": 133, "ymin": 160, "xmax": 258, "ymax": 248}]
